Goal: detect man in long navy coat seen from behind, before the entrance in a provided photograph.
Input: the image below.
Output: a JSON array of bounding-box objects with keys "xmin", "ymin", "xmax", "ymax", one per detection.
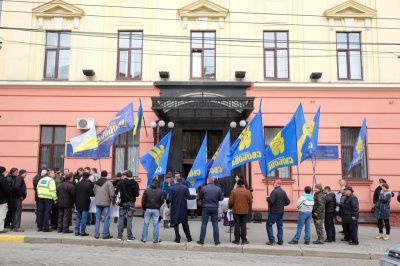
[{"xmin": 167, "ymin": 176, "xmax": 196, "ymax": 243}]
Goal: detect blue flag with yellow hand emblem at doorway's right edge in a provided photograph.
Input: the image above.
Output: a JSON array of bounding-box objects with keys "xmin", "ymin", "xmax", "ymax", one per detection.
[{"xmin": 227, "ymin": 108, "xmax": 265, "ymax": 170}]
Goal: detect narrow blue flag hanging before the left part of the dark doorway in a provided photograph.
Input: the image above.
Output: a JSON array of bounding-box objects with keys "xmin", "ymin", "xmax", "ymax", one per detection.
[{"xmin": 186, "ymin": 132, "xmax": 207, "ymax": 188}]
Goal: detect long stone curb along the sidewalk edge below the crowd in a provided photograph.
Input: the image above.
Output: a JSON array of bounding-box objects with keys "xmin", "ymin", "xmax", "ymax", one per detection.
[{"xmin": 0, "ymin": 235, "xmax": 382, "ymax": 260}]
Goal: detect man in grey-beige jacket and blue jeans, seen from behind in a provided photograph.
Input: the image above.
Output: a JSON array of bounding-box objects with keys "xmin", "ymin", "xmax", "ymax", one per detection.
[{"xmin": 94, "ymin": 171, "xmax": 115, "ymax": 239}]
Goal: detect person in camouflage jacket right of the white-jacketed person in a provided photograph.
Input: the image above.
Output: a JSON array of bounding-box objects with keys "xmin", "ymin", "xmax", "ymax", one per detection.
[{"xmin": 313, "ymin": 184, "xmax": 325, "ymax": 244}]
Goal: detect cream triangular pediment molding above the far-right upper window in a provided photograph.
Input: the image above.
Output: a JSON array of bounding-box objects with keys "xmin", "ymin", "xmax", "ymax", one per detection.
[{"xmin": 324, "ymin": 0, "xmax": 376, "ymax": 18}]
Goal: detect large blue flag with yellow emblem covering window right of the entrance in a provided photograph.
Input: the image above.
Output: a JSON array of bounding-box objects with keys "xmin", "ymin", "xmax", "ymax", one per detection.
[{"xmin": 265, "ymin": 104, "xmax": 305, "ymax": 174}]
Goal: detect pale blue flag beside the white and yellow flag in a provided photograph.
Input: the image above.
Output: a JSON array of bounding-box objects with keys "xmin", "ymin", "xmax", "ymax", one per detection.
[{"xmin": 90, "ymin": 103, "xmax": 133, "ymax": 160}]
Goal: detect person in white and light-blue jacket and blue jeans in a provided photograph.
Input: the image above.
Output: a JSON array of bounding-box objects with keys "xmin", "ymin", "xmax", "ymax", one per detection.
[{"xmin": 289, "ymin": 186, "xmax": 314, "ymax": 245}]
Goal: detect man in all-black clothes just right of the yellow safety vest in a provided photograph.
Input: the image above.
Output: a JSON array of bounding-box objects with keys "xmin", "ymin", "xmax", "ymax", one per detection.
[{"xmin": 57, "ymin": 174, "xmax": 75, "ymax": 234}]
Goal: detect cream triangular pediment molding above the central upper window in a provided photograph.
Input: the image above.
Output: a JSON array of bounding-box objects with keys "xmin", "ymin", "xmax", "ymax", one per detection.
[{"xmin": 178, "ymin": 0, "xmax": 229, "ymax": 18}]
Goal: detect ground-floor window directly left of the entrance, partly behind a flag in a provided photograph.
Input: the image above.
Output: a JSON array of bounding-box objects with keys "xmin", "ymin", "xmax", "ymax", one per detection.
[{"xmin": 113, "ymin": 130, "xmax": 140, "ymax": 176}]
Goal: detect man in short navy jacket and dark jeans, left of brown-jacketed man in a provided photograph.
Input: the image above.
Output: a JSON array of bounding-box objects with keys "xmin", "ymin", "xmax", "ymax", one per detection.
[{"xmin": 197, "ymin": 177, "xmax": 224, "ymax": 245}]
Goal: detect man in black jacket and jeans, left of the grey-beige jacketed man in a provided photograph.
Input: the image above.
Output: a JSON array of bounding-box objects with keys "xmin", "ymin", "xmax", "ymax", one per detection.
[{"xmin": 75, "ymin": 173, "xmax": 94, "ymax": 236}]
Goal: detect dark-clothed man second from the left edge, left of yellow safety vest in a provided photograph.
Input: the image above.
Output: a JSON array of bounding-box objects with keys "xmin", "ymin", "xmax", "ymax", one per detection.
[{"xmin": 11, "ymin": 169, "xmax": 27, "ymax": 232}]
